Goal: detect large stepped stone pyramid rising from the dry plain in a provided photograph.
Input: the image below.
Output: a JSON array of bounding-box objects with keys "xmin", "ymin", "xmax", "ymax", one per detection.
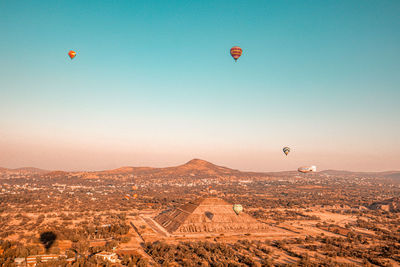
[{"xmin": 154, "ymin": 198, "xmax": 267, "ymax": 234}]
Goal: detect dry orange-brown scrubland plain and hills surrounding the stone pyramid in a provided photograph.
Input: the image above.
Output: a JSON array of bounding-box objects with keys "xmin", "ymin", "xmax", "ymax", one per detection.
[{"xmin": 0, "ymin": 160, "xmax": 400, "ymax": 266}]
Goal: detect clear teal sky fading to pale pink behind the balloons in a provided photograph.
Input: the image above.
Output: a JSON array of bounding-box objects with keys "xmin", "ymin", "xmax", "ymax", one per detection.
[{"xmin": 0, "ymin": 0, "xmax": 400, "ymax": 171}]
